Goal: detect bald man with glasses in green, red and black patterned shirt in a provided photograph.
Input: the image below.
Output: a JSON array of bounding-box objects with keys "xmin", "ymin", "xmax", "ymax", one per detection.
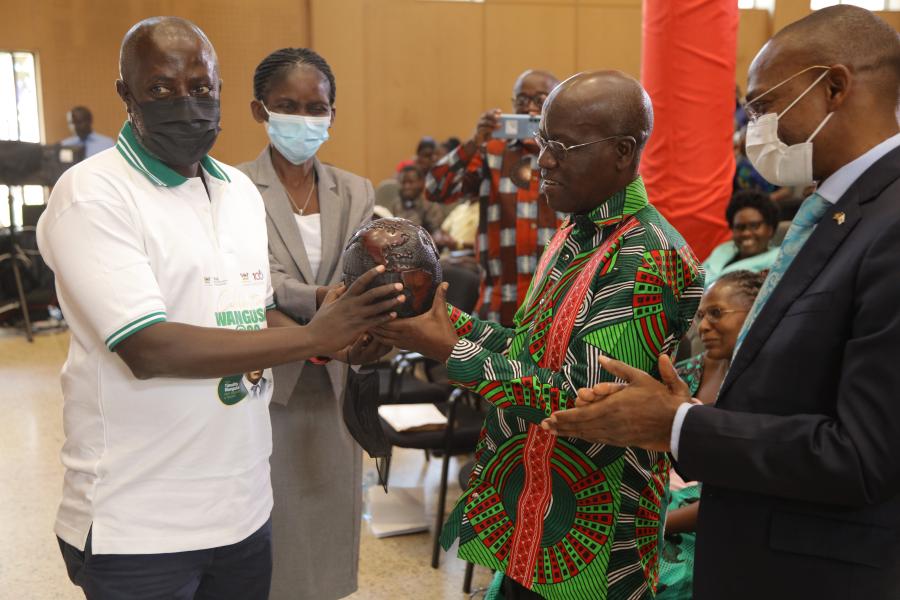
[{"xmin": 376, "ymin": 71, "xmax": 703, "ymax": 600}]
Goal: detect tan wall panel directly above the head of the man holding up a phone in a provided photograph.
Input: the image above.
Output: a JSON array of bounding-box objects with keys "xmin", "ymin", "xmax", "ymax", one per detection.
[{"xmin": 486, "ymin": 0, "xmax": 577, "ymax": 110}]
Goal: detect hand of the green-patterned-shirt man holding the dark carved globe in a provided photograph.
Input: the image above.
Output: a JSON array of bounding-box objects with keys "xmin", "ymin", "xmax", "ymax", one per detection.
[{"xmin": 371, "ymin": 282, "xmax": 459, "ymax": 363}]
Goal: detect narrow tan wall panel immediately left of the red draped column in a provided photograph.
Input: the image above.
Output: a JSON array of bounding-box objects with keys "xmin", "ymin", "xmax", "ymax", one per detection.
[{"xmin": 576, "ymin": 4, "xmax": 641, "ymax": 78}]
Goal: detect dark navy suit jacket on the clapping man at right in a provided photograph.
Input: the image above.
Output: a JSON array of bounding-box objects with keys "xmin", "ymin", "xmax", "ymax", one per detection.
[{"xmin": 678, "ymin": 148, "xmax": 900, "ymax": 600}]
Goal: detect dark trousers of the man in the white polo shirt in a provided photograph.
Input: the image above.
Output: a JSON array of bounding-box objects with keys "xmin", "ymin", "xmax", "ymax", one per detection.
[{"xmin": 57, "ymin": 520, "xmax": 272, "ymax": 600}]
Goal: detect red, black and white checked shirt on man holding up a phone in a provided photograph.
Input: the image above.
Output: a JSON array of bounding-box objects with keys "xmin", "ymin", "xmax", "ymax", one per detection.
[{"xmin": 425, "ymin": 140, "xmax": 561, "ymax": 326}]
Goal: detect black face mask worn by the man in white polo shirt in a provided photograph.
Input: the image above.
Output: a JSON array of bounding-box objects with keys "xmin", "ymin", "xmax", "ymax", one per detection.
[{"xmin": 138, "ymin": 96, "xmax": 219, "ymax": 167}]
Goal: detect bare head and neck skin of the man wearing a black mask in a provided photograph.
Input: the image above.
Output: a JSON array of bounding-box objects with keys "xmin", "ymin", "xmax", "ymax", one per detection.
[{"xmin": 116, "ymin": 18, "xmax": 222, "ymax": 177}]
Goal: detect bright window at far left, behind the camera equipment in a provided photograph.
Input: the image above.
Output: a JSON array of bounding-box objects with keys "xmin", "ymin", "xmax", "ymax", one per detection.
[{"xmin": 0, "ymin": 51, "xmax": 44, "ymax": 227}]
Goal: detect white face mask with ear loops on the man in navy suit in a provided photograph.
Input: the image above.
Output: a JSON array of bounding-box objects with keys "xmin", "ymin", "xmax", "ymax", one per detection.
[{"xmin": 747, "ymin": 66, "xmax": 834, "ymax": 186}]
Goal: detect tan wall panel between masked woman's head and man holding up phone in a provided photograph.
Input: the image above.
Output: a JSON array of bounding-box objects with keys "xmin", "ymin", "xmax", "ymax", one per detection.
[{"xmin": 364, "ymin": 0, "xmax": 484, "ymax": 182}]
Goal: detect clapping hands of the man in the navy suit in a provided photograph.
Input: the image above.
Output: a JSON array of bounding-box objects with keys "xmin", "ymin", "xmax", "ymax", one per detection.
[{"xmin": 541, "ymin": 354, "xmax": 691, "ymax": 452}]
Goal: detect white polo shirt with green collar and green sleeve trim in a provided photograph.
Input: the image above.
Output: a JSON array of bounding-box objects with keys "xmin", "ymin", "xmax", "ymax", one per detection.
[{"xmin": 38, "ymin": 123, "xmax": 274, "ymax": 554}]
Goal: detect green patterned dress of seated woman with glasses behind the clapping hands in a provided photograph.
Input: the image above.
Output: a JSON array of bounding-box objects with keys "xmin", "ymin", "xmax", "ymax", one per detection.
[{"xmin": 656, "ymin": 353, "xmax": 704, "ymax": 600}]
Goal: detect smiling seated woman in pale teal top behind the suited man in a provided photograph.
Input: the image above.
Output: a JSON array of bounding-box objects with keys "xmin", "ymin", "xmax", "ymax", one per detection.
[{"xmin": 703, "ymin": 190, "xmax": 778, "ymax": 286}]
